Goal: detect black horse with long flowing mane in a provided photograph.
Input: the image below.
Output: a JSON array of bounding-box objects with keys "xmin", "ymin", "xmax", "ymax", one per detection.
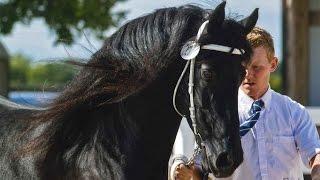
[{"xmin": 0, "ymin": 3, "xmax": 257, "ymax": 180}]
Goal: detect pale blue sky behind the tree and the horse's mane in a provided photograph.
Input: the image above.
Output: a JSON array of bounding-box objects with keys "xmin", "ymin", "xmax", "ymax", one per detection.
[{"xmin": 0, "ymin": 0, "xmax": 282, "ymax": 61}]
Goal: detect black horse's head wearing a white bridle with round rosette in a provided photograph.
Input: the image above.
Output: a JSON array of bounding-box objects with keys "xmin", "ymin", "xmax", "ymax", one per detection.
[{"xmin": 176, "ymin": 2, "xmax": 258, "ymax": 177}]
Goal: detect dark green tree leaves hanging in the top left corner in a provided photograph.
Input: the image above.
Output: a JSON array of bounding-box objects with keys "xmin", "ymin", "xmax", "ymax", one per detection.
[{"xmin": 0, "ymin": 0, "xmax": 125, "ymax": 44}]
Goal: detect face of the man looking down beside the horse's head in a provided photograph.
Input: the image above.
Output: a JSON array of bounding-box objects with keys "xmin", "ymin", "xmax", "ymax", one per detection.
[{"xmin": 240, "ymin": 46, "xmax": 278, "ymax": 100}]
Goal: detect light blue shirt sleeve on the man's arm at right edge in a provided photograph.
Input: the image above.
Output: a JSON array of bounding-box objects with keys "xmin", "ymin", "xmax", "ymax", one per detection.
[{"xmin": 292, "ymin": 104, "xmax": 320, "ymax": 168}]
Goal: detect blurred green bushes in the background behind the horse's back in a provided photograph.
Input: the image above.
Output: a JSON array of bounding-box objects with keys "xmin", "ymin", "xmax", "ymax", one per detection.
[{"xmin": 9, "ymin": 54, "xmax": 78, "ymax": 91}]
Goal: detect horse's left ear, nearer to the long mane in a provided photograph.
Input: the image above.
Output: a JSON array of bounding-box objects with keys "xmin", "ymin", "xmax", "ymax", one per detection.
[{"xmin": 208, "ymin": 1, "xmax": 226, "ymax": 32}]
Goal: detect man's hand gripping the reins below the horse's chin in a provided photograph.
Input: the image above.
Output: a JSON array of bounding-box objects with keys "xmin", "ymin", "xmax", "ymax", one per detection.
[{"xmin": 175, "ymin": 164, "xmax": 201, "ymax": 180}]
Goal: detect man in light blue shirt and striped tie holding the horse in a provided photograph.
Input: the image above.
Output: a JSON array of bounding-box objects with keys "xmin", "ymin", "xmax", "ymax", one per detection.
[{"xmin": 171, "ymin": 27, "xmax": 320, "ymax": 180}]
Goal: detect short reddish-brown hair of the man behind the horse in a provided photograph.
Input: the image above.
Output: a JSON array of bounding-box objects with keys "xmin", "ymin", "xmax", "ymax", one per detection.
[{"xmin": 247, "ymin": 27, "xmax": 274, "ymax": 60}]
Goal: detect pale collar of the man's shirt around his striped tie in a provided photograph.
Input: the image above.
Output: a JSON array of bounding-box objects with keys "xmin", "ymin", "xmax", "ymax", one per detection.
[{"xmin": 238, "ymin": 85, "xmax": 272, "ymax": 110}]
